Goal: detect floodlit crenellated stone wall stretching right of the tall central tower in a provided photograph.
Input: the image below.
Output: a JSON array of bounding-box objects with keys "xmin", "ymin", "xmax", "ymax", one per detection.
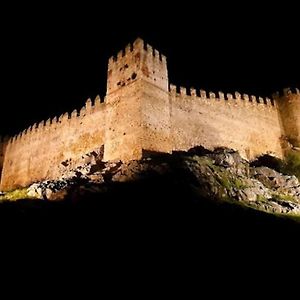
[{"xmin": 170, "ymin": 86, "xmax": 283, "ymax": 159}]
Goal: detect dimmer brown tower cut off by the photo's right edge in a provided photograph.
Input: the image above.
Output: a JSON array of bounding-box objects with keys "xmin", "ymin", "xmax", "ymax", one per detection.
[{"xmin": 274, "ymin": 89, "xmax": 300, "ymax": 147}]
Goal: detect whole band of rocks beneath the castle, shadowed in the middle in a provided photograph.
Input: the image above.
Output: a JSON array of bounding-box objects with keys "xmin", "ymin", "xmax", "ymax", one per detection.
[{"xmin": 22, "ymin": 149, "xmax": 300, "ymax": 214}]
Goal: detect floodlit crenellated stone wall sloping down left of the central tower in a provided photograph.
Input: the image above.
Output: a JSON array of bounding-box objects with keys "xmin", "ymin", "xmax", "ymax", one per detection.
[{"xmin": 1, "ymin": 98, "xmax": 105, "ymax": 190}]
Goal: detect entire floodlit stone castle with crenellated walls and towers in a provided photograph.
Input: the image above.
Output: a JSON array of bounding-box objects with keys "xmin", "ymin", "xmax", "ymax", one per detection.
[{"xmin": 0, "ymin": 39, "xmax": 300, "ymax": 191}]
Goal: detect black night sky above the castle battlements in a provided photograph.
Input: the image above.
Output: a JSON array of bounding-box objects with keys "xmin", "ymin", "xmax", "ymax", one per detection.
[{"xmin": 0, "ymin": 4, "xmax": 300, "ymax": 134}]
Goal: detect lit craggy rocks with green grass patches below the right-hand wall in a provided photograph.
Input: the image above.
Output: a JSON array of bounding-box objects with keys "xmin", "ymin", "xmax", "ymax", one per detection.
[{"xmin": 184, "ymin": 149, "xmax": 300, "ymax": 214}]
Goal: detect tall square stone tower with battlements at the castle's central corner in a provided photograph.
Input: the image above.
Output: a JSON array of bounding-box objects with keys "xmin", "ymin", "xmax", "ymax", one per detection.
[{"xmin": 104, "ymin": 39, "xmax": 171, "ymax": 161}]
